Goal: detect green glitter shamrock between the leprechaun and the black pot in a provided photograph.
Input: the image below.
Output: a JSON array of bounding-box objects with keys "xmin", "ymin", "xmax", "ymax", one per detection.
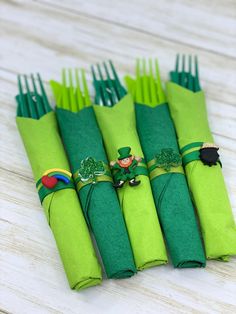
[{"xmin": 156, "ymin": 148, "xmax": 182, "ymax": 172}]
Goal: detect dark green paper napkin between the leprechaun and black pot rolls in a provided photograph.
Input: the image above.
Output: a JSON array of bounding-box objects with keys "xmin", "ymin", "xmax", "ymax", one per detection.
[{"xmin": 135, "ymin": 104, "xmax": 205, "ymax": 268}]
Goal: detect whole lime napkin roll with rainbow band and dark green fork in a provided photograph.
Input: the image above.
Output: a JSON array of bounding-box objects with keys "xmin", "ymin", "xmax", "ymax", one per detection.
[{"xmin": 16, "ymin": 75, "xmax": 101, "ymax": 290}]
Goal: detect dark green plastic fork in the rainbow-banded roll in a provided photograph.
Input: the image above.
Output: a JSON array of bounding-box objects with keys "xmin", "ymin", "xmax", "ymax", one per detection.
[{"xmin": 16, "ymin": 73, "xmax": 52, "ymax": 119}]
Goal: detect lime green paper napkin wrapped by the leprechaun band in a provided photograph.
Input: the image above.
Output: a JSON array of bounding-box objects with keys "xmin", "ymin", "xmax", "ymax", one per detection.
[{"xmin": 94, "ymin": 95, "xmax": 167, "ymax": 270}]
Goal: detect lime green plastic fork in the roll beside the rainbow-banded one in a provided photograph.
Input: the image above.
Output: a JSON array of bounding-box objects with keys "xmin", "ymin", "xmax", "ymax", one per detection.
[{"xmin": 57, "ymin": 69, "xmax": 91, "ymax": 112}]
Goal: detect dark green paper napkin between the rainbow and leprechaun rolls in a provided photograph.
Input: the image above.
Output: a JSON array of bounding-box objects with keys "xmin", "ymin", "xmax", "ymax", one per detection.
[{"xmin": 56, "ymin": 106, "xmax": 136, "ymax": 278}]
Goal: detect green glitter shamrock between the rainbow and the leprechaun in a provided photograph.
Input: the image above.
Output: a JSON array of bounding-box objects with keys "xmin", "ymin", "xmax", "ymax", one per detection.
[{"xmin": 78, "ymin": 157, "xmax": 105, "ymax": 183}]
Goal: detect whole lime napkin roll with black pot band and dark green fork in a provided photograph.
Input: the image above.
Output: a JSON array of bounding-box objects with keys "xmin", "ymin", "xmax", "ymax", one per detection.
[{"xmin": 167, "ymin": 56, "xmax": 236, "ymax": 261}]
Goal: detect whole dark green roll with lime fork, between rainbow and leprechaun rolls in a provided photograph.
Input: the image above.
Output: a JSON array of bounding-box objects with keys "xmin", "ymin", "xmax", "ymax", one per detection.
[{"xmin": 51, "ymin": 73, "xmax": 136, "ymax": 278}]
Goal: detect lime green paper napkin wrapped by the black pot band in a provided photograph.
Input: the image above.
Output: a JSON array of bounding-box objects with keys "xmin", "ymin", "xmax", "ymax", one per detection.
[{"xmin": 167, "ymin": 82, "xmax": 236, "ymax": 261}]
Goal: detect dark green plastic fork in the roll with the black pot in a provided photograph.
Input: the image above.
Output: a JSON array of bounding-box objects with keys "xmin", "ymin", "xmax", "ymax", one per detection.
[{"xmin": 170, "ymin": 54, "xmax": 201, "ymax": 92}]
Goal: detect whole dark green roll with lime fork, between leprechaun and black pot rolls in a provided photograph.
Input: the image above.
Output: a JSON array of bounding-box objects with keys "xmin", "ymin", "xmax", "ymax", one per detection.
[{"xmin": 126, "ymin": 61, "xmax": 205, "ymax": 268}]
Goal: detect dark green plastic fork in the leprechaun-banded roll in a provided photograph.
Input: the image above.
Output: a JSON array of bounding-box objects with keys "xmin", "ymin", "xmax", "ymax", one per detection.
[{"xmin": 91, "ymin": 60, "xmax": 127, "ymax": 107}]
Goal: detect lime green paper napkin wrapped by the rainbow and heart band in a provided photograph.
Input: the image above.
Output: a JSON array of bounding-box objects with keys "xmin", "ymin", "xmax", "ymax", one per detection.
[{"xmin": 16, "ymin": 112, "xmax": 101, "ymax": 290}]
